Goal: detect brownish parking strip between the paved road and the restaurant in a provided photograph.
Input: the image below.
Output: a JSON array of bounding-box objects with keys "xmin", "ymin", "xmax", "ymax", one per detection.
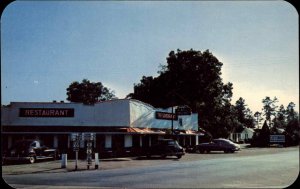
[{"xmin": 2, "ymin": 145, "xmax": 299, "ymax": 175}]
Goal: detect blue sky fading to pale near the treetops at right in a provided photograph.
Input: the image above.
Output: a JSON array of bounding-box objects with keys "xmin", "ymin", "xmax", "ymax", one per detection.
[{"xmin": 1, "ymin": 1, "xmax": 299, "ymax": 113}]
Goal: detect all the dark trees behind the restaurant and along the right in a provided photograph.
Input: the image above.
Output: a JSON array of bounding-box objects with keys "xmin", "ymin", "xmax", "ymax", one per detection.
[{"xmin": 67, "ymin": 49, "xmax": 299, "ymax": 141}]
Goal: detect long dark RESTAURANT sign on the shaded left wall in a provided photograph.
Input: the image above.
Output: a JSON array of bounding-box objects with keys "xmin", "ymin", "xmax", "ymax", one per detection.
[{"xmin": 19, "ymin": 108, "xmax": 74, "ymax": 117}]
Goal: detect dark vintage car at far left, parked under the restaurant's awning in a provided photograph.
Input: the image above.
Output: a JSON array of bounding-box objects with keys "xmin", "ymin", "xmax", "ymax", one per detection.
[{"xmin": 2, "ymin": 140, "xmax": 59, "ymax": 163}]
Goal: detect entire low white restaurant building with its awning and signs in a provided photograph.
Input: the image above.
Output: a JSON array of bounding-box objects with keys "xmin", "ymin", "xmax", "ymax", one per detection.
[{"xmin": 1, "ymin": 99, "xmax": 204, "ymax": 158}]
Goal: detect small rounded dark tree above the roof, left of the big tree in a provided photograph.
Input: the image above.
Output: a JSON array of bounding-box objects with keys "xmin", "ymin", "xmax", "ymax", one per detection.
[{"xmin": 67, "ymin": 79, "xmax": 116, "ymax": 104}]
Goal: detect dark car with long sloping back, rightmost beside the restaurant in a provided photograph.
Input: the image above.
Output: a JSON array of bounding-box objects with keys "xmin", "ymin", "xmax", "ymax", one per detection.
[{"xmin": 193, "ymin": 138, "xmax": 241, "ymax": 153}]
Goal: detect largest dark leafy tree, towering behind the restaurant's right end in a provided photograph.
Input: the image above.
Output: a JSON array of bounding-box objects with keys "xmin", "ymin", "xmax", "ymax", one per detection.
[{"xmin": 127, "ymin": 49, "xmax": 236, "ymax": 137}]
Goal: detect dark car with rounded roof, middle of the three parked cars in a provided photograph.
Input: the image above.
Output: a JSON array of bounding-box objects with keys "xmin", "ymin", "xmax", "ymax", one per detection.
[{"xmin": 146, "ymin": 139, "xmax": 185, "ymax": 159}]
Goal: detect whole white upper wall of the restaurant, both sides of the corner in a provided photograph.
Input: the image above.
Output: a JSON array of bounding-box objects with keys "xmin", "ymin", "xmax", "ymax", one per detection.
[{"xmin": 1, "ymin": 99, "xmax": 198, "ymax": 130}]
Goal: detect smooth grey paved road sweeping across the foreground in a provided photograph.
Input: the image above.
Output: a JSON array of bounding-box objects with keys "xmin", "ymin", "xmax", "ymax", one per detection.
[{"xmin": 2, "ymin": 147, "xmax": 299, "ymax": 188}]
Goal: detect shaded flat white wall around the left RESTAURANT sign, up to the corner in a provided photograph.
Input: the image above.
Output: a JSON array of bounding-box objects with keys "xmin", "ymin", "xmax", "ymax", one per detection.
[{"xmin": 1, "ymin": 100, "xmax": 129, "ymax": 127}]
